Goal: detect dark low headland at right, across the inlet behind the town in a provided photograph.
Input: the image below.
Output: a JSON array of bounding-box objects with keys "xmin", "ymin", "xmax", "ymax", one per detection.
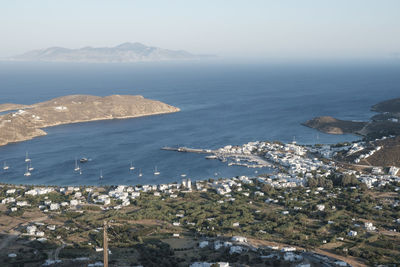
[{"xmin": 303, "ymin": 98, "xmax": 400, "ymax": 138}]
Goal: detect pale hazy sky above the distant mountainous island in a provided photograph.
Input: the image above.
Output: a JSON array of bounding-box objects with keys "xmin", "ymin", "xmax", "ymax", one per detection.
[{"xmin": 0, "ymin": 0, "xmax": 400, "ymax": 58}]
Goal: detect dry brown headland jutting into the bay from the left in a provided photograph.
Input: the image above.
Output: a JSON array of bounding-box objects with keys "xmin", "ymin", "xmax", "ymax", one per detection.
[{"xmin": 0, "ymin": 95, "xmax": 180, "ymax": 146}]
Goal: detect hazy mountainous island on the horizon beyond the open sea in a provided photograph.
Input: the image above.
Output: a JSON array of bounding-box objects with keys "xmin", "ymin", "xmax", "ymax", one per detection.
[{"xmin": 8, "ymin": 43, "xmax": 211, "ymax": 63}]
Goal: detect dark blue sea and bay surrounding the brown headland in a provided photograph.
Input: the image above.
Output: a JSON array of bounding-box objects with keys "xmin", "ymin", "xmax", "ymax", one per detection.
[{"xmin": 0, "ymin": 62, "xmax": 400, "ymax": 185}]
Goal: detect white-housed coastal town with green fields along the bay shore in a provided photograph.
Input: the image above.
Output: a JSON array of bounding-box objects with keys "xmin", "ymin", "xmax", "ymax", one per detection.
[{"xmin": 0, "ymin": 136, "xmax": 400, "ymax": 267}]
